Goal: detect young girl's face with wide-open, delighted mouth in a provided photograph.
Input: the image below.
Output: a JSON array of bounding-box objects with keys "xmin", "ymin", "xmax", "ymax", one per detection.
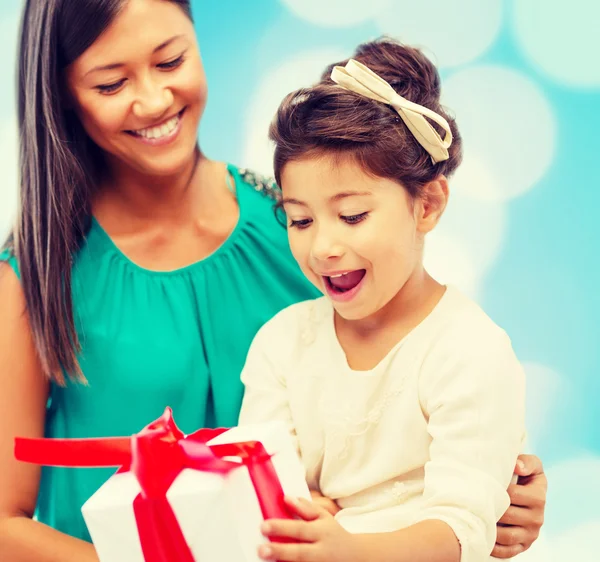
[{"xmin": 281, "ymin": 155, "xmax": 435, "ymax": 320}]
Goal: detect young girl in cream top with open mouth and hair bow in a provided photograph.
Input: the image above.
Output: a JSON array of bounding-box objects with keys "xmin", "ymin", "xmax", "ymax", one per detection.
[{"xmin": 240, "ymin": 40, "xmax": 525, "ymax": 562}]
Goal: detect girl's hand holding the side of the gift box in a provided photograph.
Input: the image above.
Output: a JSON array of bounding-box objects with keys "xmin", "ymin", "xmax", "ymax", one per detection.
[{"xmin": 258, "ymin": 497, "xmax": 360, "ymax": 562}]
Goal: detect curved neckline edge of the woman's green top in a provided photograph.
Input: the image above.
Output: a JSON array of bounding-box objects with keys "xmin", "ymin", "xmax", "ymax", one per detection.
[{"xmin": 90, "ymin": 163, "xmax": 247, "ymax": 277}]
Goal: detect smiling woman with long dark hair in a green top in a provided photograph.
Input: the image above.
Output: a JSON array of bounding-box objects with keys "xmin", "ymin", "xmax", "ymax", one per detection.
[{"xmin": 0, "ymin": 0, "xmax": 545, "ymax": 562}]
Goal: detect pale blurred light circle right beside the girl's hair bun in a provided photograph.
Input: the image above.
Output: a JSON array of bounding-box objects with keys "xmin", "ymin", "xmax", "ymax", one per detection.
[{"xmin": 442, "ymin": 66, "xmax": 556, "ymax": 201}]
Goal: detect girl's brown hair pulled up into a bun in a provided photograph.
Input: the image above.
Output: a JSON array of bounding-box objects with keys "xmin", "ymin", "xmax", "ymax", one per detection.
[{"xmin": 269, "ymin": 38, "xmax": 462, "ymax": 198}]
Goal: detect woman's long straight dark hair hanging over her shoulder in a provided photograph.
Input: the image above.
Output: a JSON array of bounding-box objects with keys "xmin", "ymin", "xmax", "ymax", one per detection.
[{"xmin": 7, "ymin": 0, "xmax": 191, "ymax": 384}]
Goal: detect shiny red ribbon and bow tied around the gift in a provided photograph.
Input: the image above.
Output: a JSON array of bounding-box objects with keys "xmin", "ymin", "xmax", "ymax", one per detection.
[{"xmin": 15, "ymin": 408, "xmax": 292, "ymax": 562}]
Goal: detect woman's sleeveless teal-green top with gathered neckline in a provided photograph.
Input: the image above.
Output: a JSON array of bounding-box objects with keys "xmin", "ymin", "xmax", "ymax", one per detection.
[{"xmin": 0, "ymin": 166, "xmax": 317, "ymax": 541}]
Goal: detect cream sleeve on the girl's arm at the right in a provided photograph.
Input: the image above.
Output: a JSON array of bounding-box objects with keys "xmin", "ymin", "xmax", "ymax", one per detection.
[{"xmin": 415, "ymin": 332, "xmax": 525, "ymax": 562}]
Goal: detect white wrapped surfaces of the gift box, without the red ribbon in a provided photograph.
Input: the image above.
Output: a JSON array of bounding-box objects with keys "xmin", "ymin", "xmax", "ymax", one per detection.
[{"xmin": 82, "ymin": 422, "xmax": 310, "ymax": 562}]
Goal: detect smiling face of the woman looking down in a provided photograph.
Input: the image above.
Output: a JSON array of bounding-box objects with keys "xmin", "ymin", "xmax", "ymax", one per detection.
[{"xmin": 66, "ymin": 0, "xmax": 207, "ymax": 176}]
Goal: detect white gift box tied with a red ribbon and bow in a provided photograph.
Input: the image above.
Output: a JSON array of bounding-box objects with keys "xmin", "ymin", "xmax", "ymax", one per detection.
[{"xmin": 15, "ymin": 409, "xmax": 310, "ymax": 562}]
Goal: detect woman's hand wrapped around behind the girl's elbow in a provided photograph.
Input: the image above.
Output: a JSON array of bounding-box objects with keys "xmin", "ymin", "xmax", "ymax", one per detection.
[{"xmin": 492, "ymin": 455, "xmax": 548, "ymax": 558}]
